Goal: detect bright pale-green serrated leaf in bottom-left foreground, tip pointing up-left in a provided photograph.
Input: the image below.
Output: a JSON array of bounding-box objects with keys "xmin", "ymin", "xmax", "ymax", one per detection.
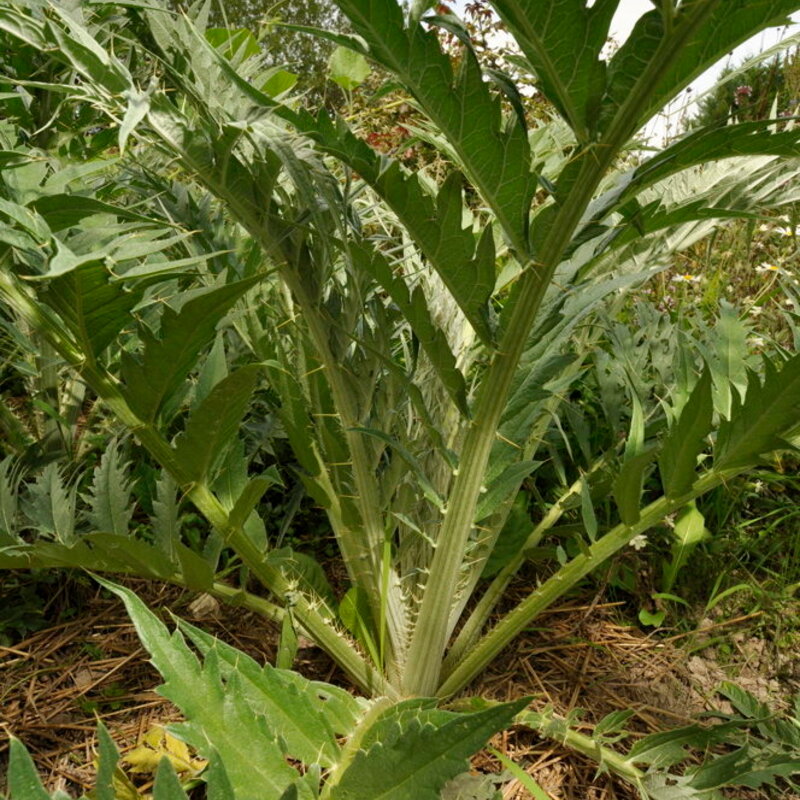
[{"xmin": 96, "ymin": 577, "xmax": 299, "ymax": 800}]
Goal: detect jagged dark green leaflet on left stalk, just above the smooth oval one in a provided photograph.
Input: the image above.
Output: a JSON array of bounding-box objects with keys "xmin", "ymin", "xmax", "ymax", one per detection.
[{"xmin": 122, "ymin": 276, "xmax": 258, "ymax": 422}]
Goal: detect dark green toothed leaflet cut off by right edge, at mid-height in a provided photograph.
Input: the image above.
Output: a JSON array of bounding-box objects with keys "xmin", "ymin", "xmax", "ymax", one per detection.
[{"xmin": 714, "ymin": 355, "xmax": 800, "ymax": 471}]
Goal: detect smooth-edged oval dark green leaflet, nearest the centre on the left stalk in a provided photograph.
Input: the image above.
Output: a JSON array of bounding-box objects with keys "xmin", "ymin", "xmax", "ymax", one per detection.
[{"xmin": 175, "ymin": 364, "xmax": 261, "ymax": 483}]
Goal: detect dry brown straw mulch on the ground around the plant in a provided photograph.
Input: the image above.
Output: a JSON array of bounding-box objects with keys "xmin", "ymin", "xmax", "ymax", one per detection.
[{"xmin": 0, "ymin": 580, "xmax": 792, "ymax": 800}]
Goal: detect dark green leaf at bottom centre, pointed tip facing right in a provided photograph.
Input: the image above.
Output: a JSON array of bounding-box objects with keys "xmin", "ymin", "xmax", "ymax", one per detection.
[{"xmin": 330, "ymin": 698, "xmax": 528, "ymax": 800}]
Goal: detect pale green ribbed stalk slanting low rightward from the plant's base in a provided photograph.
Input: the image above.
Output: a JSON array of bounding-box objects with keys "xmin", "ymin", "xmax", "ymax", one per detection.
[{"xmin": 436, "ymin": 472, "xmax": 735, "ymax": 697}]
